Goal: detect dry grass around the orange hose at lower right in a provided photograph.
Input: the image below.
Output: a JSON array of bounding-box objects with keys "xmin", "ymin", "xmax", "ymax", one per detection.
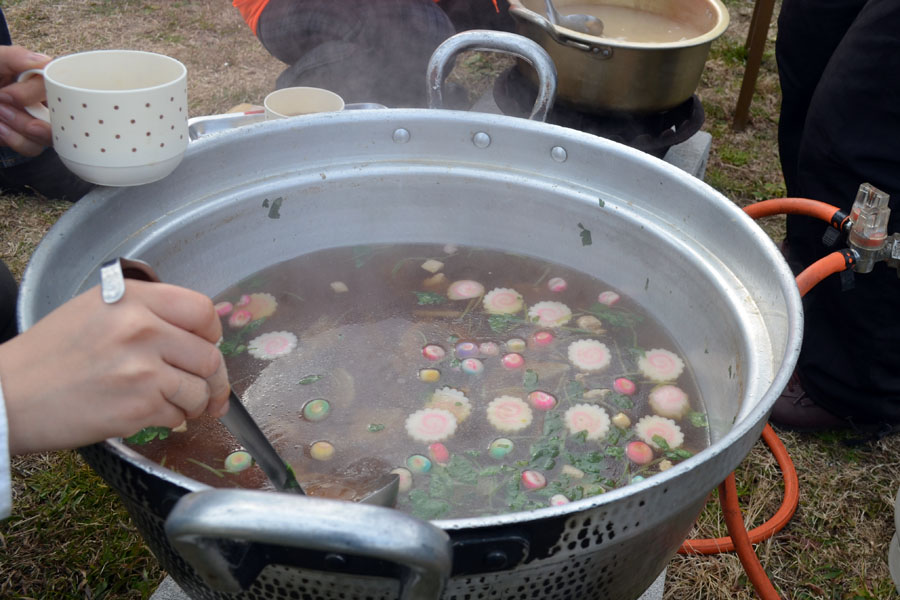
[{"xmin": 665, "ymin": 432, "xmax": 900, "ymax": 600}]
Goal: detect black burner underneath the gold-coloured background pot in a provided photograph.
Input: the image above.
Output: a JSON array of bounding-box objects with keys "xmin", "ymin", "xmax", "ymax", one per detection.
[{"xmin": 494, "ymin": 67, "xmax": 705, "ymax": 158}]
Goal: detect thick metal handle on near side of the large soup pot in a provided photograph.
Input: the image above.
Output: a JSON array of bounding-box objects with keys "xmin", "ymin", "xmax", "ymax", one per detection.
[{"xmin": 165, "ymin": 489, "xmax": 453, "ymax": 600}]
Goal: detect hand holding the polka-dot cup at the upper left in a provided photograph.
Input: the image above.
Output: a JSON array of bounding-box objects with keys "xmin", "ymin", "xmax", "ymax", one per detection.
[{"xmin": 0, "ymin": 46, "xmax": 53, "ymax": 156}]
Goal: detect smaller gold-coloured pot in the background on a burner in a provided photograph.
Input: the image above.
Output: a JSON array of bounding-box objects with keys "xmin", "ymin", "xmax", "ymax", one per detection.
[{"xmin": 509, "ymin": 0, "xmax": 729, "ymax": 114}]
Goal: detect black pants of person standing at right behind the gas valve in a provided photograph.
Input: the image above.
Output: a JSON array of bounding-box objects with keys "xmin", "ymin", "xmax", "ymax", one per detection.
[{"xmin": 776, "ymin": 0, "xmax": 900, "ymax": 423}]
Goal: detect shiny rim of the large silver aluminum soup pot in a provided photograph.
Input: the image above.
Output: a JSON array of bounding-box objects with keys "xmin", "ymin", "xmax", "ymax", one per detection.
[{"xmin": 29, "ymin": 109, "xmax": 802, "ymax": 530}]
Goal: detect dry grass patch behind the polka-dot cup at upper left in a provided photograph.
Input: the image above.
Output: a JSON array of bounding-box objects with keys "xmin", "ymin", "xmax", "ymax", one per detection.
[{"xmin": 4, "ymin": 0, "xmax": 283, "ymax": 115}]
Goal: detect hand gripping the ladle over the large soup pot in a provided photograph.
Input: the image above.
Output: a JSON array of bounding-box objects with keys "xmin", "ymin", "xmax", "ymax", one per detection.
[{"xmin": 0, "ymin": 279, "xmax": 229, "ymax": 455}]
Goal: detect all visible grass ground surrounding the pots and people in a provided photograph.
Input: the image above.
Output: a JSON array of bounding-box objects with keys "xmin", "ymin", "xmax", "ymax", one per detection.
[{"xmin": 0, "ymin": 0, "xmax": 900, "ymax": 600}]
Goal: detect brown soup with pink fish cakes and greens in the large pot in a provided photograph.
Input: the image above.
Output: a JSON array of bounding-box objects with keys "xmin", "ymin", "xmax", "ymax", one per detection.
[{"xmin": 129, "ymin": 245, "xmax": 709, "ymax": 518}]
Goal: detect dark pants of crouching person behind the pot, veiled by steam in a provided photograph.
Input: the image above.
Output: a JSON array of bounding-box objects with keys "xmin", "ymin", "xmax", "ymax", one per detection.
[{"xmin": 256, "ymin": 0, "xmax": 456, "ymax": 107}]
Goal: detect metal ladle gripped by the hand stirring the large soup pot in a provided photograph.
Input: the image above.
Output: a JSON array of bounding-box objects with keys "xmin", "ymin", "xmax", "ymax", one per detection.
[{"xmin": 100, "ymin": 258, "xmax": 400, "ymax": 507}]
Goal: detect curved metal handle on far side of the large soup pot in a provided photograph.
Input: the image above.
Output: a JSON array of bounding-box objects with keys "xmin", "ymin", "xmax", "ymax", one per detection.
[{"xmin": 427, "ymin": 29, "xmax": 556, "ymax": 121}]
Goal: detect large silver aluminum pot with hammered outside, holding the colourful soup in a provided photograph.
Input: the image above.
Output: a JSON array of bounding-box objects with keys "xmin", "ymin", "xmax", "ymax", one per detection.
[{"xmin": 19, "ymin": 39, "xmax": 802, "ymax": 600}]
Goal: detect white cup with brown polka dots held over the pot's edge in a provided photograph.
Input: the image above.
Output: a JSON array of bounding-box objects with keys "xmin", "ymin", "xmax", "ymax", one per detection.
[{"xmin": 19, "ymin": 50, "xmax": 189, "ymax": 186}]
